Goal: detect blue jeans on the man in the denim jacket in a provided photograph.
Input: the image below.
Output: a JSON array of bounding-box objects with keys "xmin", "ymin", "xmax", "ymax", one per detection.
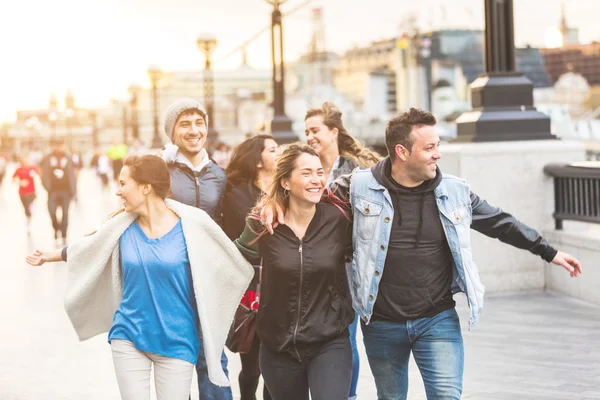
[{"xmin": 361, "ymin": 308, "xmax": 464, "ymax": 400}]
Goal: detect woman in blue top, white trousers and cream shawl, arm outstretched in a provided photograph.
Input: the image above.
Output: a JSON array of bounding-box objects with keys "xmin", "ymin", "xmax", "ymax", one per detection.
[{"xmin": 27, "ymin": 155, "xmax": 252, "ymax": 400}]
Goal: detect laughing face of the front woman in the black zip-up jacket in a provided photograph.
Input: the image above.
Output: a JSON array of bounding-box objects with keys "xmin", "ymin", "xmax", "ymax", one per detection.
[{"xmin": 281, "ymin": 153, "xmax": 325, "ymax": 204}]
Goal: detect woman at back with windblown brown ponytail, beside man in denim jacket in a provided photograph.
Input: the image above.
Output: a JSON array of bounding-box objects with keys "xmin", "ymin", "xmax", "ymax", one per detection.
[{"xmin": 304, "ymin": 102, "xmax": 382, "ymax": 399}]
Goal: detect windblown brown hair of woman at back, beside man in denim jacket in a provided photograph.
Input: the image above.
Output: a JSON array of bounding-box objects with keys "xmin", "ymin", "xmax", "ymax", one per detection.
[{"xmin": 304, "ymin": 101, "xmax": 382, "ymax": 168}]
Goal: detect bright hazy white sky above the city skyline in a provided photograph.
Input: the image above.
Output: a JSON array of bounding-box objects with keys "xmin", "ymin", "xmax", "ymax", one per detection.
[{"xmin": 0, "ymin": 0, "xmax": 600, "ymax": 121}]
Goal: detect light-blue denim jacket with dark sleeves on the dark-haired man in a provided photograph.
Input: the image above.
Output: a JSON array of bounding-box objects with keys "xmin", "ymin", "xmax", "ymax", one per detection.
[{"xmin": 346, "ymin": 169, "xmax": 557, "ymax": 327}]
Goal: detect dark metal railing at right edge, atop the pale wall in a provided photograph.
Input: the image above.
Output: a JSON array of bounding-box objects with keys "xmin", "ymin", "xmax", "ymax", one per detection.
[{"xmin": 544, "ymin": 163, "xmax": 600, "ymax": 229}]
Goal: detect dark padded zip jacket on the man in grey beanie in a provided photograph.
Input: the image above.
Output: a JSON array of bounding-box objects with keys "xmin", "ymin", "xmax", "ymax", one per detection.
[{"xmin": 167, "ymin": 160, "xmax": 227, "ymax": 225}]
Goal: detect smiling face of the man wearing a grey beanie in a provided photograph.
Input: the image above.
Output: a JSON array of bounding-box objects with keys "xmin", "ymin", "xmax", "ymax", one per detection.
[{"xmin": 173, "ymin": 111, "xmax": 208, "ymax": 156}]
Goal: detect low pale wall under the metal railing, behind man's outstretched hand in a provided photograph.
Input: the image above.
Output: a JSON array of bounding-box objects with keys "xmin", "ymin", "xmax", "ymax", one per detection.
[{"xmin": 544, "ymin": 221, "xmax": 600, "ymax": 304}]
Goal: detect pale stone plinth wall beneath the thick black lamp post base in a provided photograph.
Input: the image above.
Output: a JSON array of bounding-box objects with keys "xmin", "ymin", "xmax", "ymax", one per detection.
[{"xmin": 439, "ymin": 140, "xmax": 584, "ymax": 292}]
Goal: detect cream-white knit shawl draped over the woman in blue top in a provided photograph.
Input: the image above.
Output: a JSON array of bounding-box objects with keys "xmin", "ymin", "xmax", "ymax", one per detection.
[{"xmin": 65, "ymin": 199, "xmax": 254, "ymax": 386}]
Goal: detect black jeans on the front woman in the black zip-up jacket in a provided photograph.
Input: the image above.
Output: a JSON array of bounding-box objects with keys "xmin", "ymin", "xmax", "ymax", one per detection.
[{"xmin": 259, "ymin": 335, "xmax": 352, "ymax": 400}]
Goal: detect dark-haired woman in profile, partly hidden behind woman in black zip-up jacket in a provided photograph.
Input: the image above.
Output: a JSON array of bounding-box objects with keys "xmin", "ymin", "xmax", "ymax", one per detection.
[{"xmin": 223, "ymin": 135, "xmax": 278, "ymax": 400}]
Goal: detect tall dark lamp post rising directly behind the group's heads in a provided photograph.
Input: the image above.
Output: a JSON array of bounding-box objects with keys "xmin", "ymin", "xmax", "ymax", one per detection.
[{"xmin": 265, "ymin": 0, "xmax": 298, "ymax": 144}]
